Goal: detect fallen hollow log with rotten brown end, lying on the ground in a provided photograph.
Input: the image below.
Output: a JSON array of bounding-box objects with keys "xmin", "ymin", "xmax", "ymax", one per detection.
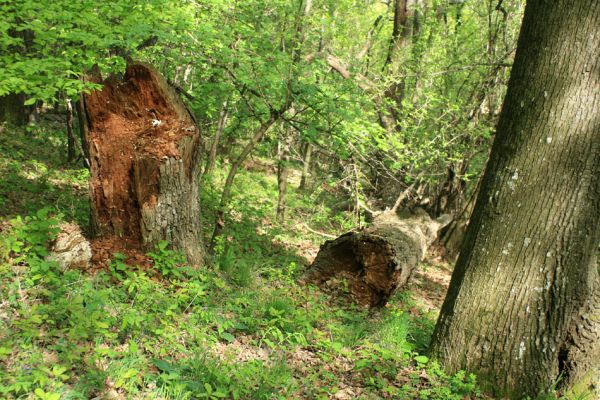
[{"xmin": 303, "ymin": 212, "xmax": 450, "ymax": 307}]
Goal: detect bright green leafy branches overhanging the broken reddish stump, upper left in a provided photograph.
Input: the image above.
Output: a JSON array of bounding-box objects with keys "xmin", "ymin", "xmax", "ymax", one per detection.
[{"xmin": 0, "ymin": 0, "xmax": 189, "ymax": 104}]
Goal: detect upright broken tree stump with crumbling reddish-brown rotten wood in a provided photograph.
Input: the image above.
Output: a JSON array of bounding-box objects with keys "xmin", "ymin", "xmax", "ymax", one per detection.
[{"xmin": 84, "ymin": 63, "xmax": 203, "ymax": 265}]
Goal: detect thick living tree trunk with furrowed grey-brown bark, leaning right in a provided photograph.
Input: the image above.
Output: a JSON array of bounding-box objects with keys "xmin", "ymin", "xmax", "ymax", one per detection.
[{"xmin": 431, "ymin": 0, "xmax": 600, "ymax": 398}]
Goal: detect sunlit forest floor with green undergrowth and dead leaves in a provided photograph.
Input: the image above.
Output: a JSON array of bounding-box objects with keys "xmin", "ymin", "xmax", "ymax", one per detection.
[{"xmin": 0, "ymin": 123, "xmax": 481, "ymax": 400}]
